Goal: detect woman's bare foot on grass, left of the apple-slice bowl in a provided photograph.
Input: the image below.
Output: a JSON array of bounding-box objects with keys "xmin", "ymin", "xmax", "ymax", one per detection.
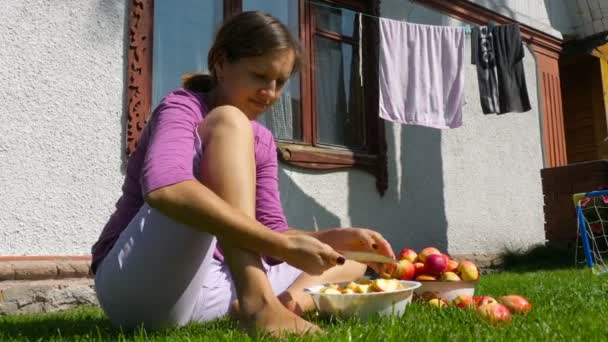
[{"xmin": 230, "ymin": 301, "xmax": 322, "ymax": 336}]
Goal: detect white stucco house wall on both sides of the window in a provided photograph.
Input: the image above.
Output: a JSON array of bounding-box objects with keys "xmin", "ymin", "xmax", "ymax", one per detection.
[{"xmin": 0, "ymin": 0, "xmax": 544, "ymax": 255}]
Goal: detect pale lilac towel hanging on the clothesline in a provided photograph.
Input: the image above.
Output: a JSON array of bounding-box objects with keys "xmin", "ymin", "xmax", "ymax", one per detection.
[{"xmin": 379, "ymin": 18, "xmax": 465, "ymax": 128}]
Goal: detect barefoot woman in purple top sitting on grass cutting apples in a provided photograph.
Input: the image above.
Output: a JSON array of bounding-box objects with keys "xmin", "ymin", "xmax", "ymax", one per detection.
[{"xmin": 92, "ymin": 12, "xmax": 393, "ymax": 334}]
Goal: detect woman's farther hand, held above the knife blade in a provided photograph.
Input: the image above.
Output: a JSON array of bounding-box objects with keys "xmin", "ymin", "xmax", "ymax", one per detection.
[{"xmin": 318, "ymin": 227, "xmax": 395, "ymax": 273}]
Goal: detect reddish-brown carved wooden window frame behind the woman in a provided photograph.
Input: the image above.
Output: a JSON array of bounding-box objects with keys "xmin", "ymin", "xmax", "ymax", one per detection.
[{"xmin": 126, "ymin": 0, "xmax": 388, "ymax": 195}]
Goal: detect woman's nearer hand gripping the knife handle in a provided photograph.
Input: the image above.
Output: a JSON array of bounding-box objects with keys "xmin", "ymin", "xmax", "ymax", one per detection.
[{"xmin": 281, "ymin": 234, "xmax": 345, "ymax": 275}]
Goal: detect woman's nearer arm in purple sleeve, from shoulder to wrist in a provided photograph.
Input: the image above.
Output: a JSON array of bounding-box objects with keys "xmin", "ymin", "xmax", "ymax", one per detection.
[{"xmin": 140, "ymin": 95, "xmax": 288, "ymax": 255}]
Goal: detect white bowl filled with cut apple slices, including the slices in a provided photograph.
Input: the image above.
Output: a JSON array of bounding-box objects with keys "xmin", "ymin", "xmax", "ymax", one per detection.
[{"xmin": 304, "ymin": 278, "xmax": 420, "ymax": 320}]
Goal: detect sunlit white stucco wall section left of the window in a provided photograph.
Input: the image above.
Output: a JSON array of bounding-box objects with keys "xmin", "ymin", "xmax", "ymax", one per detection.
[{"xmin": 0, "ymin": 0, "xmax": 126, "ymax": 255}]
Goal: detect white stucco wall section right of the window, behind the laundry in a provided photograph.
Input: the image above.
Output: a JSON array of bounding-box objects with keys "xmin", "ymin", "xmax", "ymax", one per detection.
[{"xmin": 280, "ymin": 0, "xmax": 544, "ymax": 254}]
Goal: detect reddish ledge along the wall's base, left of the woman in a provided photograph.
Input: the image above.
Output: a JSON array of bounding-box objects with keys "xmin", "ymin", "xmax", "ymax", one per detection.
[{"xmin": 0, "ymin": 256, "xmax": 91, "ymax": 281}]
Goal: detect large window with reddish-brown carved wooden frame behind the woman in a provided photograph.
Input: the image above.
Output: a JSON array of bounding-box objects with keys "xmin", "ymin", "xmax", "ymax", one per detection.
[{"xmin": 127, "ymin": 0, "xmax": 387, "ymax": 194}]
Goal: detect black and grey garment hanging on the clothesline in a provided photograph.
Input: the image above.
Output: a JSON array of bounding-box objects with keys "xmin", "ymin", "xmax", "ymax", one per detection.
[{"xmin": 471, "ymin": 24, "xmax": 531, "ymax": 114}]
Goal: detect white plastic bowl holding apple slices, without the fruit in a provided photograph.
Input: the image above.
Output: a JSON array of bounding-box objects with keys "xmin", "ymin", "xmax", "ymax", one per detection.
[{"xmin": 304, "ymin": 280, "xmax": 420, "ymax": 320}]
